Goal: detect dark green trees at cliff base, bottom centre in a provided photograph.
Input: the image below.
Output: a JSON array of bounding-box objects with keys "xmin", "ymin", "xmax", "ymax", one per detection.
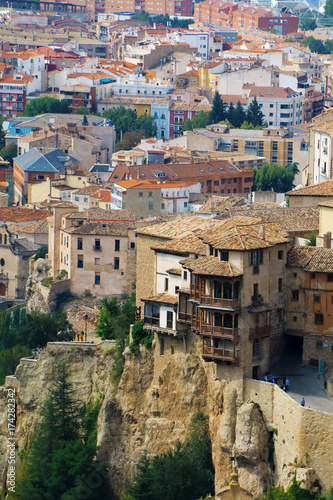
[{"xmin": 122, "ymin": 411, "xmax": 214, "ymax": 500}]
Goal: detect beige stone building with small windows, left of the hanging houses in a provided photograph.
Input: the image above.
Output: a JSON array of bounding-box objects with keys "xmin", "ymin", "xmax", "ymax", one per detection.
[{"xmin": 49, "ymin": 203, "xmax": 136, "ymax": 296}]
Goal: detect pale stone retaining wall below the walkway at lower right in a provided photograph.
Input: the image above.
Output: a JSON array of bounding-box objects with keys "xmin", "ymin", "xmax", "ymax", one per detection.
[{"xmin": 244, "ymin": 379, "xmax": 333, "ymax": 490}]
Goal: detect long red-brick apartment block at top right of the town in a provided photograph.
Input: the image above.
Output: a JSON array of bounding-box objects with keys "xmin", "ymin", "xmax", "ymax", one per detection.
[{"xmin": 194, "ymin": 0, "xmax": 298, "ymax": 35}]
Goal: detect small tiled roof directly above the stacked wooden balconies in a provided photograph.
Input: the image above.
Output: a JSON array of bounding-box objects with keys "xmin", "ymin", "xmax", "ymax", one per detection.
[{"xmin": 180, "ymin": 257, "xmax": 243, "ymax": 277}]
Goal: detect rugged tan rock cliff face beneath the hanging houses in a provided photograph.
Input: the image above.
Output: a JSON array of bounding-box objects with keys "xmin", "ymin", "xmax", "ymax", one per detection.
[{"xmin": 0, "ymin": 343, "xmax": 271, "ymax": 496}]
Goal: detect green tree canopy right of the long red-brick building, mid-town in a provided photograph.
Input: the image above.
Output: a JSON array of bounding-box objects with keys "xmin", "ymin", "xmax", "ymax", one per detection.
[{"xmin": 253, "ymin": 163, "xmax": 295, "ymax": 193}]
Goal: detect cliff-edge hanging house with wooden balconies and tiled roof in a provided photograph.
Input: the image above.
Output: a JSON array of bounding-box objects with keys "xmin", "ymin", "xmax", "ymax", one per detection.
[{"xmin": 137, "ymin": 216, "xmax": 288, "ymax": 378}]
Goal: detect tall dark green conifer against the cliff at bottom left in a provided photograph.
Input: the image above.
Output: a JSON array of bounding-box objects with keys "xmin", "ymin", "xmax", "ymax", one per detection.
[{"xmin": 9, "ymin": 366, "xmax": 105, "ymax": 500}]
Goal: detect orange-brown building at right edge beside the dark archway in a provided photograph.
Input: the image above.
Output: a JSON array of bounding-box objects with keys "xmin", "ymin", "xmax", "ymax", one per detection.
[{"xmin": 286, "ymin": 247, "xmax": 333, "ymax": 366}]
